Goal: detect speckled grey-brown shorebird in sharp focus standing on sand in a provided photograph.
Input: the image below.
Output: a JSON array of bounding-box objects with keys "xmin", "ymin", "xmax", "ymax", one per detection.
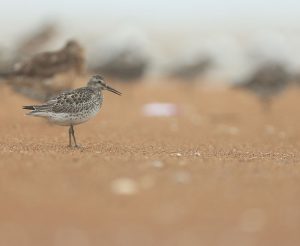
[{"xmin": 23, "ymin": 75, "xmax": 122, "ymax": 147}]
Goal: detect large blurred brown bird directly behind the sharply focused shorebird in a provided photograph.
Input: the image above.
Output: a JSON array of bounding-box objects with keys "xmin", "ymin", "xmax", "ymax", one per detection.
[{"xmin": 0, "ymin": 40, "xmax": 85, "ymax": 100}]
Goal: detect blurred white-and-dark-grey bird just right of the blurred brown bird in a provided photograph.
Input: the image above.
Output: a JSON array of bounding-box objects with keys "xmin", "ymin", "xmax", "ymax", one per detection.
[{"xmin": 89, "ymin": 26, "xmax": 153, "ymax": 83}]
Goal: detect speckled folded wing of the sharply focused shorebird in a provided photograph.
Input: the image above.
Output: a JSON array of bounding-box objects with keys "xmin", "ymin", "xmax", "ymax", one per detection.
[{"xmin": 47, "ymin": 87, "xmax": 96, "ymax": 113}]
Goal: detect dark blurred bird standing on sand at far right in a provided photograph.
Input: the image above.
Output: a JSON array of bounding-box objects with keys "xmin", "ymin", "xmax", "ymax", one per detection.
[{"xmin": 234, "ymin": 63, "xmax": 290, "ymax": 111}]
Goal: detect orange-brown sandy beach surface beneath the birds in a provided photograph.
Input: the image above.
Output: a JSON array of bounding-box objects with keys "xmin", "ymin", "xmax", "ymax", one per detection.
[{"xmin": 0, "ymin": 84, "xmax": 300, "ymax": 246}]
